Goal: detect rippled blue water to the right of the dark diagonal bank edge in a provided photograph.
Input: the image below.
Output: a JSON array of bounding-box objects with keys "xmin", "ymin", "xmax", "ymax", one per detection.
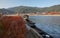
[{"xmin": 30, "ymin": 16, "xmax": 60, "ymax": 38}]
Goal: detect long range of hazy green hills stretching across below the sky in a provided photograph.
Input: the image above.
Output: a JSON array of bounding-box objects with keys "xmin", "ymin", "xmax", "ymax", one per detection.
[{"xmin": 0, "ymin": 5, "xmax": 60, "ymax": 14}]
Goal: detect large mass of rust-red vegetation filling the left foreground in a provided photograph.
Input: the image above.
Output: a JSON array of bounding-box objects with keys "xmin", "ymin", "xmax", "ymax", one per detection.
[{"xmin": 0, "ymin": 16, "xmax": 27, "ymax": 38}]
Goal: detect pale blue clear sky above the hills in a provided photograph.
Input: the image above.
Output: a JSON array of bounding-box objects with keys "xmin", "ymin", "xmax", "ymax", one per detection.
[{"xmin": 0, "ymin": 0, "xmax": 60, "ymax": 8}]
